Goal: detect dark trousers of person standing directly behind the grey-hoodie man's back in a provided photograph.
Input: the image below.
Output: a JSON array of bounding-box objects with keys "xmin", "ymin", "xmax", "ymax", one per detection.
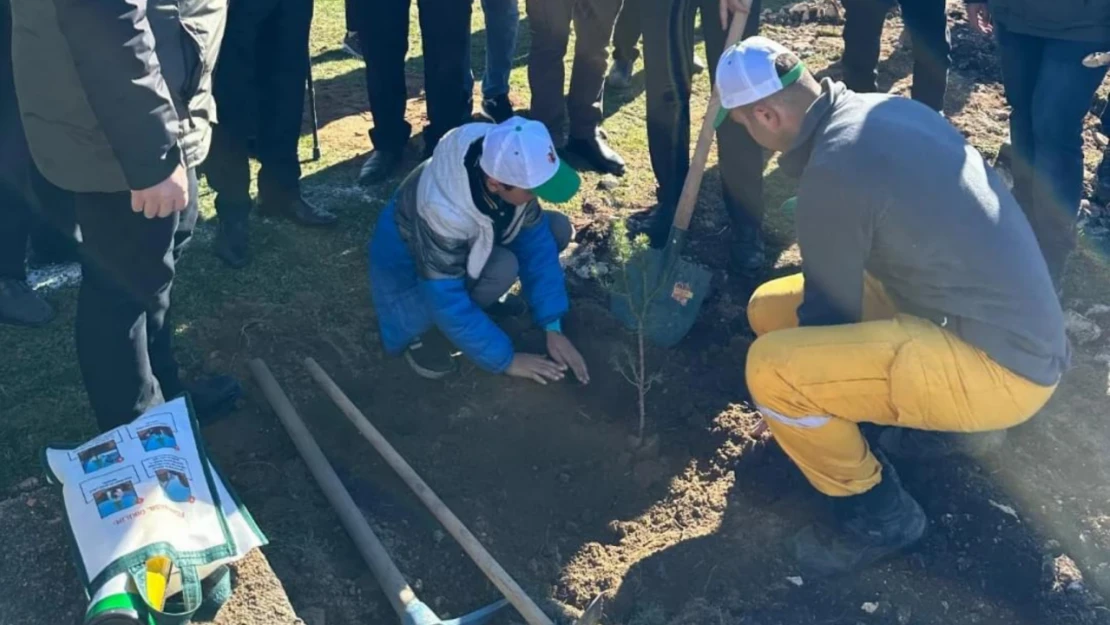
[{"xmin": 841, "ymin": 0, "xmax": 952, "ymax": 111}]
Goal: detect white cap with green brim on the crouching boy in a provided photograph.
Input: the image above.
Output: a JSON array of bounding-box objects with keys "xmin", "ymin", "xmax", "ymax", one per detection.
[{"xmin": 478, "ymin": 117, "xmax": 582, "ymax": 204}]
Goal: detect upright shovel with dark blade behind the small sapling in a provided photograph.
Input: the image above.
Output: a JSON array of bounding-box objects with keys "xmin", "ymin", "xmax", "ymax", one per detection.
[{"xmin": 609, "ymin": 1, "xmax": 751, "ymax": 347}]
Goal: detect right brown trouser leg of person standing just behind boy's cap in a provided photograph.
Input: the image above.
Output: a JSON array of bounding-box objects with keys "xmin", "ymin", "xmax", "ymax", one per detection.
[{"xmin": 566, "ymin": 0, "xmax": 620, "ymax": 140}]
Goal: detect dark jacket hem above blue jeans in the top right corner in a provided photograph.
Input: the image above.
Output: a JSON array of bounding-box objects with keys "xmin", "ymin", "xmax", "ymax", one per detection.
[{"xmin": 988, "ymin": 0, "xmax": 1110, "ymax": 46}]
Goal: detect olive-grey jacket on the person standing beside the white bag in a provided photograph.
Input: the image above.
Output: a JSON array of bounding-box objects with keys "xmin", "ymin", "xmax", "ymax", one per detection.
[{"xmin": 11, "ymin": 0, "xmax": 228, "ymax": 193}]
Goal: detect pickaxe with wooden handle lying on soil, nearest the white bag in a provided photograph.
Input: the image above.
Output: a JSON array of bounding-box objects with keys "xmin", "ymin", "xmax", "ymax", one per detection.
[{"xmin": 250, "ymin": 359, "xmax": 508, "ymax": 625}]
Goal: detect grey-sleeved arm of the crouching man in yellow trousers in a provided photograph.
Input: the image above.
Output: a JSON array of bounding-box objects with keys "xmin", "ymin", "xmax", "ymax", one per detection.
[{"xmin": 795, "ymin": 170, "xmax": 871, "ymax": 326}]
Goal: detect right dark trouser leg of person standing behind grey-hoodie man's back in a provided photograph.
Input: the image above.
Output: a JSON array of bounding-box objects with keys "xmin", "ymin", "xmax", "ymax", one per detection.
[{"xmin": 899, "ymin": 0, "xmax": 952, "ymax": 111}]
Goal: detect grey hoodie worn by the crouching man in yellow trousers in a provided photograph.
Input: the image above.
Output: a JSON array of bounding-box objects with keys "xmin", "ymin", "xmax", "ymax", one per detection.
[{"xmin": 780, "ymin": 80, "xmax": 1069, "ymax": 385}]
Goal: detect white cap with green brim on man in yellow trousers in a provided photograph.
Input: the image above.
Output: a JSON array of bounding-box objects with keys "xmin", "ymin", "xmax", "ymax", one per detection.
[{"xmin": 716, "ymin": 37, "xmax": 806, "ymax": 127}]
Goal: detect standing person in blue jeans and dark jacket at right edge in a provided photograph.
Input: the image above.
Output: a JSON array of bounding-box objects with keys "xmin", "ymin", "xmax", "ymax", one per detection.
[{"xmin": 967, "ymin": 0, "xmax": 1110, "ymax": 292}]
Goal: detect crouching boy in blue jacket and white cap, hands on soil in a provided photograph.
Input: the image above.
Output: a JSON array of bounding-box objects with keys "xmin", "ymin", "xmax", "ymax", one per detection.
[{"xmin": 370, "ymin": 118, "xmax": 589, "ymax": 384}]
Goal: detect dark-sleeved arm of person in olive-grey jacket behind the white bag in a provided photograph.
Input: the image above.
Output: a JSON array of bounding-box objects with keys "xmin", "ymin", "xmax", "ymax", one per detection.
[{"xmin": 48, "ymin": 0, "xmax": 182, "ymax": 190}]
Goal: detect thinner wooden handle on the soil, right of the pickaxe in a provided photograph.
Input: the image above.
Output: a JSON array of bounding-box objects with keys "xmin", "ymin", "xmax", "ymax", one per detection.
[{"xmin": 304, "ymin": 359, "xmax": 554, "ymax": 625}]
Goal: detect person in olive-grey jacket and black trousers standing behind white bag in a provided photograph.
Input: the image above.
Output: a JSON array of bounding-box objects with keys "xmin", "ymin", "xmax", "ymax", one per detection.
[{"xmin": 12, "ymin": 0, "xmax": 241, "ymax": 430}]
